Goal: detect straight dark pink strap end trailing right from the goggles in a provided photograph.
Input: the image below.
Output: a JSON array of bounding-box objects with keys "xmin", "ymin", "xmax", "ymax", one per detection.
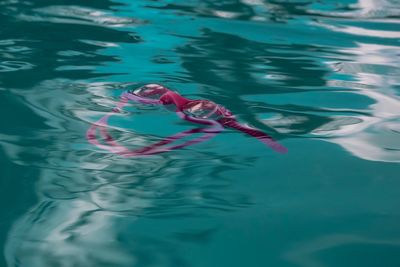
[{"xmin": 218, "ymin": 118, "xmax": 288, "ymax": 153}]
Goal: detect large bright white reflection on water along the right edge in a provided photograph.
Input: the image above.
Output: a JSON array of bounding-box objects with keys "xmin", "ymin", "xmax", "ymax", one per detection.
[{"xmin": 317, "ymin": 44, "xmax": 400, "ymax": 162}]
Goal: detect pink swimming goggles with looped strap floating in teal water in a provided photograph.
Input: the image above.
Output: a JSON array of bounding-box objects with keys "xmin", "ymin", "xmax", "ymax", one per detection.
[{"xmin": 86, "ymin": 84, "xmax": 287, "ymax": 157}]
